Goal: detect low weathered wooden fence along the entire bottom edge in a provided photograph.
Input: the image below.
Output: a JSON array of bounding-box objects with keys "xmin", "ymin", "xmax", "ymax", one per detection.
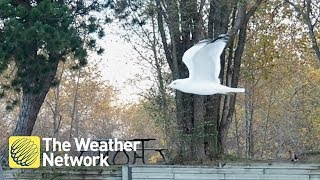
[{"xmin": 4, "ymin": 163, "xmax": 320, "ymax": 180}]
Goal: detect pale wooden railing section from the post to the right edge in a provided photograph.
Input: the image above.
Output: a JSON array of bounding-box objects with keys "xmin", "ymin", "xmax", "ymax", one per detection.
[{"xmin": 122, "ymin": 163, "xmax": 320, "ymax": 180}]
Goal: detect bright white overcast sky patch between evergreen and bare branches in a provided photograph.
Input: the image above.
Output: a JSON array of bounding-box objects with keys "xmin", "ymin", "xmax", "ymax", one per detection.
[{"xmin": 93, "ymin": 24, "xmax": 152, "ymax": 103}]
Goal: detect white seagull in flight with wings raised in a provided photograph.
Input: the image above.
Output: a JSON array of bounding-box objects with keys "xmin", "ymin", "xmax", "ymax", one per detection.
[{"xmin": 169, "ymin": 34, "xmax": 245, "ymax": 95}]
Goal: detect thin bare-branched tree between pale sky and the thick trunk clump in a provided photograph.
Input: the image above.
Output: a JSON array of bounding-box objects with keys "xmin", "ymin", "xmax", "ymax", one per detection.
[{"xmin": 115, "ymin": 1, "xmax": 174, "ymax": 142}]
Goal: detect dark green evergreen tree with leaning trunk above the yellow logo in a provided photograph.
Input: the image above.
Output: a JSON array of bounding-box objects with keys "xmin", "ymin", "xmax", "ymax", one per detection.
[{"xmin": 0, "ymin": 0, "xmax": 104, "ymax": 135}]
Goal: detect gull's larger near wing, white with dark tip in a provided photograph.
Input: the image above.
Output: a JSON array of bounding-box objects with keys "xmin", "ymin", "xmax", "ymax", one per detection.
[{"xmin": 189, "ymin": 35, "xmax": 229, "ymax": 83}]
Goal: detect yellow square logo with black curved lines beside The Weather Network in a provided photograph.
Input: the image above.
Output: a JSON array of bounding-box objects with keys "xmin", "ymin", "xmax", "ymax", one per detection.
[{"xmin": 9, "ymin": 136, "xmax": 40, "ymax": 168}]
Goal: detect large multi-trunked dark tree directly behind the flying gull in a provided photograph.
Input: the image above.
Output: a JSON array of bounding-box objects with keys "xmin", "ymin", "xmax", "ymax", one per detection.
[{"xmin": 156, "ymin": 0, "xmax": 262, "ymax": 159}]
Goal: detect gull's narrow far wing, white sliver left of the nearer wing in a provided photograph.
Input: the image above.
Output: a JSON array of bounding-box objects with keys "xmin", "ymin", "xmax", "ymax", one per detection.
[{"xmin": 182, "ymin": 39, "xmax": 211, "ymax": 77}]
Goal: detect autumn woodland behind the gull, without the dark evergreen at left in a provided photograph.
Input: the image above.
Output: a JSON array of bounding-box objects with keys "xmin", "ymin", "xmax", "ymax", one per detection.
[{"xmin": 0, "ymin": 0, "xmax": 320, "ymax": 163}]
